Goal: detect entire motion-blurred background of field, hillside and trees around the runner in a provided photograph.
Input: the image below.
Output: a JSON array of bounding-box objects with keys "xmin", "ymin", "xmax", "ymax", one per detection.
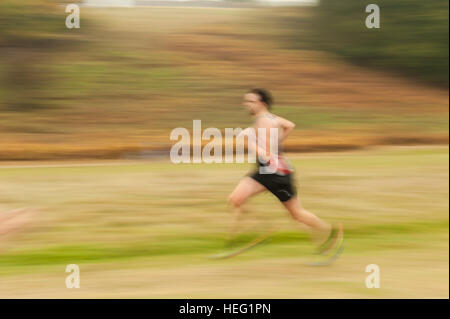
[{"xmin": 0, "ymin": 0, "xmax": 449, "ymax": 298}]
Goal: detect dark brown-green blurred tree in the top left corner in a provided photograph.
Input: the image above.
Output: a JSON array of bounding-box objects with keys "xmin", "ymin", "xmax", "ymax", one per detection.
[{"xmin": 0, "ymin": 0, "xmax": 80, "ymax": 111}]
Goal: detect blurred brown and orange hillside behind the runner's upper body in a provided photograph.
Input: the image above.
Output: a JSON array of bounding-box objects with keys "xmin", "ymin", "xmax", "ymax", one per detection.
[{"xmin": 0, "ymin": 0, "xmax": 448, "ymax": 160}]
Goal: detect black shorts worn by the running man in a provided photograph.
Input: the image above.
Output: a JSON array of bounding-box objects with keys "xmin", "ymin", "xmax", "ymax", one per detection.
[{"xmin": 249, "ymin": 170, "xmax": 297, "ymax": 202}]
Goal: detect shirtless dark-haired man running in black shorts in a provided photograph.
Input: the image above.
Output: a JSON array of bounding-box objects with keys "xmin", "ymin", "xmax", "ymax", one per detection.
[{"xmin": 228, "ymin": 89, "xmax": 343, "ymax": 254}]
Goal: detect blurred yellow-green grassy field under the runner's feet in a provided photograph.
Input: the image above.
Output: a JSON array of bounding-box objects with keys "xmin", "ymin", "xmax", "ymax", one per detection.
[{"xmin": 0, "ymin": 146, "xmax": 449, "ymax": 298}]
